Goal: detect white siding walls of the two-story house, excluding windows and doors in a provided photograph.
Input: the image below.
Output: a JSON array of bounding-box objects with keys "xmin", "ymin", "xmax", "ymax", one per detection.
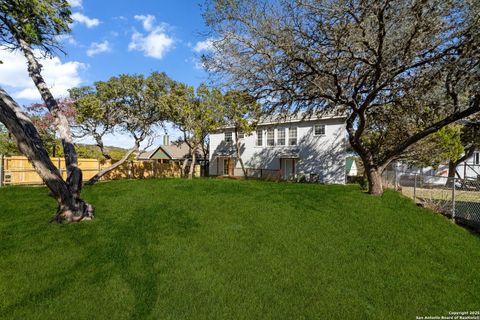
[{"xmin": 210, "ymin": 118, "xmax": 346, "ymax": 184}]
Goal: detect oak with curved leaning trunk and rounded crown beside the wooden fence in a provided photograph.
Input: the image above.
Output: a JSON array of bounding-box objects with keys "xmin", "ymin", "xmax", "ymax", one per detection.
[{"xmin": 70, "ymin": 72, "xmax": 173, "ymax": 184}]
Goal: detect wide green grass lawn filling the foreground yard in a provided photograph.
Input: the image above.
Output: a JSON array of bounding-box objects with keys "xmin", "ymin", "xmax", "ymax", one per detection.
[{"xmin": 0, "ymin": 179, "xmax": 480, "ymax": 319}]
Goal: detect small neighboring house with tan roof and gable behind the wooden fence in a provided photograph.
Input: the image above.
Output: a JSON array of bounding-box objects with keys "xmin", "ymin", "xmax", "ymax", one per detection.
[{"xmin": 137, "ymin": 142, "xmax": 205, "ymax": 164}]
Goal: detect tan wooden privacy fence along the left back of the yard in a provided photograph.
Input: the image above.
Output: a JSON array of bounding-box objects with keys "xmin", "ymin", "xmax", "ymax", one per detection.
[{"xmin": 0, "ymin": 156, "xmax": 200, "ymax": 186}]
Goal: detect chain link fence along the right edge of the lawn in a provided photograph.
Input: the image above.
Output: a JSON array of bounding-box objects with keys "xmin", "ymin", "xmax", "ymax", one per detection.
[{"xmin": 382, "ymin": 171, "xmax": 480, "ymax": 230}]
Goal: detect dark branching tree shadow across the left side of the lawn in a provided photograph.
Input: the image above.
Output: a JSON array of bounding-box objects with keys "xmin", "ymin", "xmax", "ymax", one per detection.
[{"xmin": 2, "ymin": 205, "xmax": 200, "ymax": 319}]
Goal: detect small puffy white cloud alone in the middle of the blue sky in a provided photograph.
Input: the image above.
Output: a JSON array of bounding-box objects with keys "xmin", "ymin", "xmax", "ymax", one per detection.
[{"xmin": 128, "ymin": 15, "xmax": 174, "ymax": 59}]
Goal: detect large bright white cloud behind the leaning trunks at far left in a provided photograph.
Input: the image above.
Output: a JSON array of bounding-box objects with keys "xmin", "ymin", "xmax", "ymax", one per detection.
[{"xmin": 0, "ymin": 47, "xmax": 87, "ymax": 100}]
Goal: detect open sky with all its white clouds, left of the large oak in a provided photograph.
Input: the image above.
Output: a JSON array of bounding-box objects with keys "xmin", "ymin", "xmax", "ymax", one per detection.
[{"xmin": 0, "ymin": 0, "xmax": 214, "ymax": 147}]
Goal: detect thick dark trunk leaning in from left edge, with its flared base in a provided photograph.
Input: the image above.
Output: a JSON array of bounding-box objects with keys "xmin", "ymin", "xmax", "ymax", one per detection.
[{"xmin": 0, "ymin": 88, "xmax": 93, "ymax": 222}]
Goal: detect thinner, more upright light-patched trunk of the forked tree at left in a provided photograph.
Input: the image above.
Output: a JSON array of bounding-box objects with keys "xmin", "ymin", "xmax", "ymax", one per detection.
[{"xmin": 17, "ymin": 39, "xmax": 82, "ymax": 197}]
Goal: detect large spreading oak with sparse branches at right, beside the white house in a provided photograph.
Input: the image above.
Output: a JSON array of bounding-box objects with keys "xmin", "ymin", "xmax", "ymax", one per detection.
[{"xmin": 204, "ymin": 0, "xmax": 480, "ymax": 195}]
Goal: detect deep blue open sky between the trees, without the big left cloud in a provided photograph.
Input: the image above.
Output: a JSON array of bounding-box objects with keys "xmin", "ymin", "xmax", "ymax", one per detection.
[{"xmin": 65, "ymin": 0, "xmax": 210, "ymax": 86}]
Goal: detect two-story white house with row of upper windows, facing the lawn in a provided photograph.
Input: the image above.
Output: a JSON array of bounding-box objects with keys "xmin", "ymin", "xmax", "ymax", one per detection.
[{"xmin": 209, "ymin": 115, "xmax": 346, "ymax": 184}]
